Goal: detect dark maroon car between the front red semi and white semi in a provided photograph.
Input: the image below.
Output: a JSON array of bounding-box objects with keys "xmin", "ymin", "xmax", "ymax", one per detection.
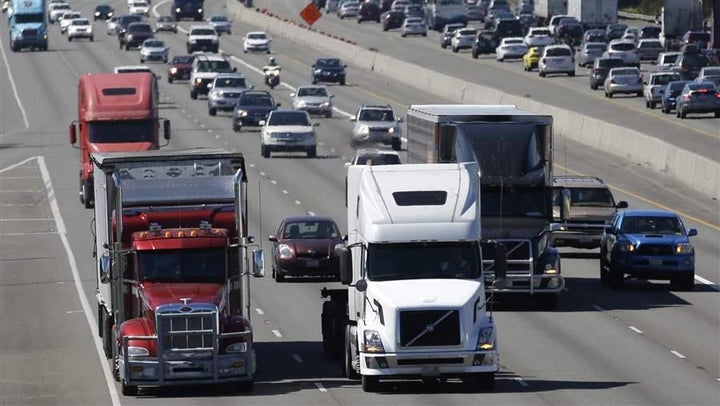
[{"xmin": 268, "ymin": 216, "xmax": 343, "ymax": 282}]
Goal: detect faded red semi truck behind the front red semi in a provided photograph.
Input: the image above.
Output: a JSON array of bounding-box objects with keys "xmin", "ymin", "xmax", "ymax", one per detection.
[{"xmin": 69, "ymin": 72, "xmax": 170, "ymax": 208}]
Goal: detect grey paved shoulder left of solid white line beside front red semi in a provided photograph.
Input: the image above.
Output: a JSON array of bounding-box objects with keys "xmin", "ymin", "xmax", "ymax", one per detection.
[{"xmin": 0, "ymin": 159, "xmax": 109, "ymax": 405}]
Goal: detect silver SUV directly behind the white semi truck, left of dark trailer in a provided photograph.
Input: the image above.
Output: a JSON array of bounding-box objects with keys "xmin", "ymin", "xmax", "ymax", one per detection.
[{"xmin": 350, "ymin": 105, "xmax": 402, "ymax": 151}]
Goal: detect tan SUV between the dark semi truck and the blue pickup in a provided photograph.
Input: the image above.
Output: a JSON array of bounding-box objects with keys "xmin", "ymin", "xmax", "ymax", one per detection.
[{"xmin": 551, "ymin": 175, "xmax": 628, "ymax": 249}]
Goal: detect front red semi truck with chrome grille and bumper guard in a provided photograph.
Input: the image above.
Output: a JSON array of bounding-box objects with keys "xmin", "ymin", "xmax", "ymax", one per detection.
[{"xmin": 90, "ymin": 150, "xmax": 264, "ymax": 396}]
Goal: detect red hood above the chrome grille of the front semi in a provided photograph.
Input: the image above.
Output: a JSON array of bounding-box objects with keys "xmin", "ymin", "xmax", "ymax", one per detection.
[{"xmin": 140, "ymin": 282, "xmax": 223, "ymax": 311}]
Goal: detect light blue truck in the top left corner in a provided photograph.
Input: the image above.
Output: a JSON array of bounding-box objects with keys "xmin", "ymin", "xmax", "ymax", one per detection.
[{"xmin": 8, "ymin": 0, "xmax": 48, "ymax": 52}]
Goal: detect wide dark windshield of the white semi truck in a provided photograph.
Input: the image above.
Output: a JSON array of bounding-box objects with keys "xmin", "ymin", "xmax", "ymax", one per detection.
[{"xmin": 367, "ymin": 242, "xmax": 480, "ymax": 281}]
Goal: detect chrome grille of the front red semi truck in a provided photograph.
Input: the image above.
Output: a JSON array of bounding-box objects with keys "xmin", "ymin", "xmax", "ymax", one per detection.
[{"xmin": 157, "ymin": 311, "xmax": 218, "ymax": 350}]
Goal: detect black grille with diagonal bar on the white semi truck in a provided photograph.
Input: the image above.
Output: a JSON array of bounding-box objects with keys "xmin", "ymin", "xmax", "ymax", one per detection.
[{"xmin": 400, "ymin": 310, "xmax": 460, "ymax": 347}]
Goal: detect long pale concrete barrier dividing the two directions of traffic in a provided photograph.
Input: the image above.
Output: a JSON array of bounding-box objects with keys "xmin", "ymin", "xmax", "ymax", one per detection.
[{"xmin": 227, "ymin": 0, "xmax": 720, "ymax": 198}]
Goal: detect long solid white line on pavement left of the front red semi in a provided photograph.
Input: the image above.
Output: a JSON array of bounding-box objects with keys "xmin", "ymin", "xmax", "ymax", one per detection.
[{"xmin": 35, "ymin": 156, "xmax": 120, "ymax": 406}]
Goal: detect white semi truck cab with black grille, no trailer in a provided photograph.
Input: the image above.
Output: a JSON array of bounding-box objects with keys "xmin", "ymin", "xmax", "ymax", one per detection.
[{"xmin": 322, "ymin": 162, "xmax": 501, "ymax": 392}]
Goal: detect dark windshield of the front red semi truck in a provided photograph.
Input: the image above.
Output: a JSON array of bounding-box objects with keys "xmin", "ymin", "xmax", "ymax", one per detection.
[{"xmin": 137, "ymin": 248, "xmax": 227, "ymax": 283}]
